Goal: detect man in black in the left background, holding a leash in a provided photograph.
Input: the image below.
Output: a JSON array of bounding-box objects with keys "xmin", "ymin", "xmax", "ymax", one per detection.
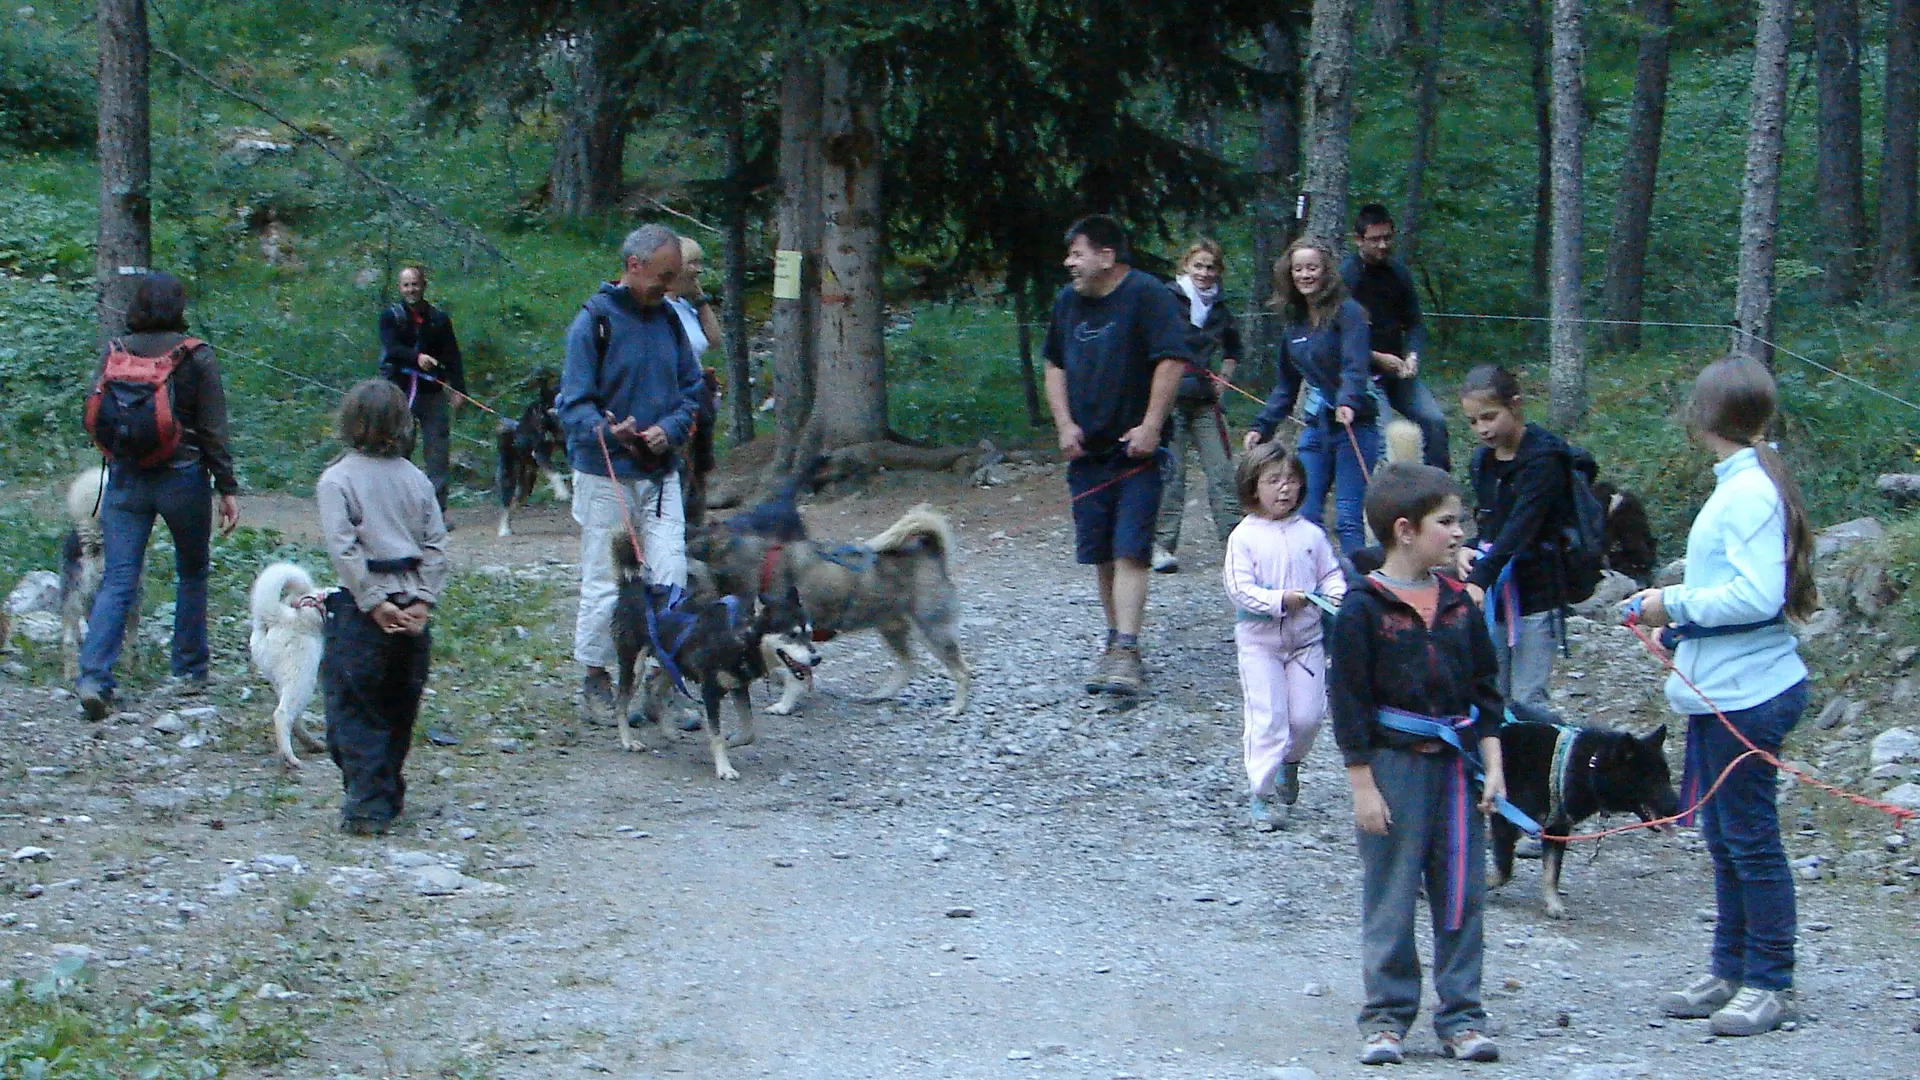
[{"xmin": 380, "ymin": 265, "xmax": 467, "ymax": 513}]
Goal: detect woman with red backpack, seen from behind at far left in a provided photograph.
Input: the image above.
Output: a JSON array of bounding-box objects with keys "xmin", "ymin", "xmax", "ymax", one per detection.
[{"xmin": 77, "ymin": 273, "xmax": 240, "ymax": 721}]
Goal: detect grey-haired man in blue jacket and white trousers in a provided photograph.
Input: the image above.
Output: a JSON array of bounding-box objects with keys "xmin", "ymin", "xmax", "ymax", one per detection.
[{"xmin": 559, "ymin": 225, "xmax": 701, "ymax": 719}]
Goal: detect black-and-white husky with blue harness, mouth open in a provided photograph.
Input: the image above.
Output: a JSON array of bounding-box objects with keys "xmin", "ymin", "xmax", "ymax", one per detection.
[{"xmin": 612, "ymin": 532, "xmax": 820, "ymax": 780}]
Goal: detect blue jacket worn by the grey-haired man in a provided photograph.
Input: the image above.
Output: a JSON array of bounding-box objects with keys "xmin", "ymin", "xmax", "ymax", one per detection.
[{"xmin": 557, "ymin": 281, "xmax": 701, "ymax": 480}]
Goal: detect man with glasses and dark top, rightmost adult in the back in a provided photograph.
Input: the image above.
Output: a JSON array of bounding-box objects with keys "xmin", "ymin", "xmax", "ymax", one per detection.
[{"xmin": 1340, "ymin": 202, "xmax": 1453, "ymax": 471}]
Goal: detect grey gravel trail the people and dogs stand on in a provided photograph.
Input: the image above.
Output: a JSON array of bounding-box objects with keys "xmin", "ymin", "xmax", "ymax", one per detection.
[{"xmin": 0, "ymin": 473, "xmax": 1920, "ymax": 1080}]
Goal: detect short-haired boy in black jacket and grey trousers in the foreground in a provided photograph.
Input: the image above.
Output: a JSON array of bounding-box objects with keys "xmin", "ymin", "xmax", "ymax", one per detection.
[{"xmin": 1327, "ymin": 463, "xmax": 1507, "ymax": 1065}]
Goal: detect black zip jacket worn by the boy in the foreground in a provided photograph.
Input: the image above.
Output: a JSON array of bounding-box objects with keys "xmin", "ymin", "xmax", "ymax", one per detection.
[{"xmin": 1327, "ymin": 577, "xmax": 1505, "ymax": 765}]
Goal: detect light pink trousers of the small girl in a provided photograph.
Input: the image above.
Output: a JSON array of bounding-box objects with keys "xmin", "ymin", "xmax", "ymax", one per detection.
[{"xmin": 1233, "ymin": 623, "xmax": 1327, "ymax": 796}]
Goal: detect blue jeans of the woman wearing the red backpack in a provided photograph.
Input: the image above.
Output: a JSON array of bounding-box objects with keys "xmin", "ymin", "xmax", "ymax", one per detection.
[{"xmin": 81, "ymin": 461, "xmax": 213, "ymax": 690}]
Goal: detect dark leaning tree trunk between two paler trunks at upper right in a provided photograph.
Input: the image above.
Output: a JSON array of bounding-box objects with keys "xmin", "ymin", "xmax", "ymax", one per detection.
[{"xmin": 1605, "ymin": 0, "xmax": 1674, "ymax": 348}]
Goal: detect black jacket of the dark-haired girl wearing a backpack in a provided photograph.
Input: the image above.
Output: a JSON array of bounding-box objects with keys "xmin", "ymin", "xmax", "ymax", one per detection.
[{"xmin": 1467, "ymin": 425, "xmax": 1572, "ymax": 615}]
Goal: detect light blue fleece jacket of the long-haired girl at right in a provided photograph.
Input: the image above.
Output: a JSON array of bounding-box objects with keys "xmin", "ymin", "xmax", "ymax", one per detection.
[{"xmin": 1661, "ymin": 448, "xmax": 1807, "ymax": 715}]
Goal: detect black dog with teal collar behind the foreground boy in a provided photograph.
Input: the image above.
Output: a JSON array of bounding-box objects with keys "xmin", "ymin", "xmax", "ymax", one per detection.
[{"xmin": 1490, "ymin": 705, "xmax": 1680, "ymax": 919}]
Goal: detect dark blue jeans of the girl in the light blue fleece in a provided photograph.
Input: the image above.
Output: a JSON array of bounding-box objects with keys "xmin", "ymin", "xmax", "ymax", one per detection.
[{"xmin": 1688, "ymin": 682, "xmax": 1807, "ymax": 990}]
